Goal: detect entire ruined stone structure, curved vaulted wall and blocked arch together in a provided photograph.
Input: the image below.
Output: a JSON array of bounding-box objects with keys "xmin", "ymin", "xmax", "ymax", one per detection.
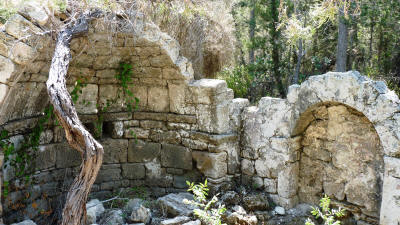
[{"xmin": 0, "ymin": 6, "xmax": 400, "ymax": 225}]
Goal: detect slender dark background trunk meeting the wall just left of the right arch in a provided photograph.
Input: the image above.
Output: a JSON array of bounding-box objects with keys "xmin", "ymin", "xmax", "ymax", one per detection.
[{"xmin": 269, "ymin": 0, "xmax": 286, "ymax": 98}]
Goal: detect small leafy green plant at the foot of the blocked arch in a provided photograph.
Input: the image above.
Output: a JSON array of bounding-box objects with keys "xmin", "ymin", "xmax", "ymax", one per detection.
[{"xmin": 305, "ymin": 195, "xmax": 345, "ymax": 225}]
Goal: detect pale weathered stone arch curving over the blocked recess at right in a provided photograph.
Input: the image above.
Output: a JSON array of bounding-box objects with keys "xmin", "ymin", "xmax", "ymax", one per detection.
[{"xmin": 287, "ymin": 72, "xmax": 400, "ymax": 224}]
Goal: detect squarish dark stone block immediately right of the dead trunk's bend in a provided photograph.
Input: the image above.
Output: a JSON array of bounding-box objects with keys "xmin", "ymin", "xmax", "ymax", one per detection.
[{"xmin": 101, "ymin": 138, "xmax": 128, "ymax": 163}]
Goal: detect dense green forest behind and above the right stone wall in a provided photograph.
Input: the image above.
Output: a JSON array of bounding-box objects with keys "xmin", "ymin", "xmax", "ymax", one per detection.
[{"xmin": 220, "ymin": 0, "xmax": 400, "ymax": 102}]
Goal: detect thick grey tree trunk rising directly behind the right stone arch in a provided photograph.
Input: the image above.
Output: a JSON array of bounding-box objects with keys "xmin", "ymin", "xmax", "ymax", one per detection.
[{"xmin": 336, "ymin": 3, "xmax": 348, "ymax": 72}]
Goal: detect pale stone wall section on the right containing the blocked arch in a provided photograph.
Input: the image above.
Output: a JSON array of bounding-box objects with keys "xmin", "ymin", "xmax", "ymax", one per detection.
[{"xmin": 240, "ymin": 72, "xmax": 400, "ymax": 224}]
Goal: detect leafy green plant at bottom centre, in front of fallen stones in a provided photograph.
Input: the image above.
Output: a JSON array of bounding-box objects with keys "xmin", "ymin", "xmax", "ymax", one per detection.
[{"xmin": 183, "ymin": 180, "xmax": 226, "ymax": 225}]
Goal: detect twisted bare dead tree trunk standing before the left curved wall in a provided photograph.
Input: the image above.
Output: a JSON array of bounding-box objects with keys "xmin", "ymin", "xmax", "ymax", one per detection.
[{"xmin": 46, "ymin": 12, "xmax": 104, "ymax": 225}]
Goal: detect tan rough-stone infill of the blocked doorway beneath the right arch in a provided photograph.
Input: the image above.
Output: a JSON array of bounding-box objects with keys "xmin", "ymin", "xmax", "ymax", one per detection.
[{"xmin": 294, "ymin": 102, "xmax": 384, "ymax": 224}]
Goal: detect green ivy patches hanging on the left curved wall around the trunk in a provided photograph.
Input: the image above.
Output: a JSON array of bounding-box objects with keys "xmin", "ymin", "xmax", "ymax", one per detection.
[{"xmin": 0, "ymin": 62, "xmax": 139, "ymax": 197}]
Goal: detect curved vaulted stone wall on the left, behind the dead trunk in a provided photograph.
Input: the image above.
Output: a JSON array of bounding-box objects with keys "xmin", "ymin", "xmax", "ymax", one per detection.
[{"xmin": 0, "ymin": 7, "xmax": 239, "ymax": 223}]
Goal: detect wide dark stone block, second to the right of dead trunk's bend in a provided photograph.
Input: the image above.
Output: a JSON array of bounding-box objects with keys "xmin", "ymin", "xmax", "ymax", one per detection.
[{"xmin": 128, "ymin": 140, "xmax": 161, "ymax": 162}]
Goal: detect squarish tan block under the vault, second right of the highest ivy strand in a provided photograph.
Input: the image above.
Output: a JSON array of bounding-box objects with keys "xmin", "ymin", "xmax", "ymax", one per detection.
[{"xmin": 147, "ymin": 87, "xmax": 169, "ymax": 112}]
